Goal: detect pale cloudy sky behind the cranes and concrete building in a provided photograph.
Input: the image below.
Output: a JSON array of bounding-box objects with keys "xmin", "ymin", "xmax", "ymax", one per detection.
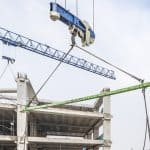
[{"xmin": 0, "ymin": 0, "xmax": 150, "ymax": 150}]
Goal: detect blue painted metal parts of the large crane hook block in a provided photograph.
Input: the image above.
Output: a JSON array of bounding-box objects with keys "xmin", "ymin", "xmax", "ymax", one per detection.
[{"xmin": 50, "ymin": 2, "xmax": 95, "ymax": 39}]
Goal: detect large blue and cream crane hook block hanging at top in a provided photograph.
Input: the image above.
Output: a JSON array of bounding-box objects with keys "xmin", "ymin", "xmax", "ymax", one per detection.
[{"xmin": 50, "ymin": 3, "xmax": 95, "ymax": 46}]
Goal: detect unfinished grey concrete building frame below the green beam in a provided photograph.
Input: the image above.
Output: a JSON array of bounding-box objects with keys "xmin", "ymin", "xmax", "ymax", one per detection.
[{"xmin": 0, "ymin": 74, "xmax": 111, "ymax": 150}]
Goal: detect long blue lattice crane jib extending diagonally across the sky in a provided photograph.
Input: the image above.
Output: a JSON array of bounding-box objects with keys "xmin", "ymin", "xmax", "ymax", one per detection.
[{"xmin": 0, "ymin": 27, "xmax": 115, "ymax": 79}]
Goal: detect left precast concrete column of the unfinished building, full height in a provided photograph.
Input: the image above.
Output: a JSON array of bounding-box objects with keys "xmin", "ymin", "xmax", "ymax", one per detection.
[{"xmin": 17, "ymin": 74, "xmax": 29, "ymax": 150}]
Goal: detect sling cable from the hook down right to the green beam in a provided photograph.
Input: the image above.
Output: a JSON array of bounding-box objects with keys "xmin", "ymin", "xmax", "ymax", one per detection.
[{"xmin": 75, "ymin": 45, "xmax": 144, "ymax": 83}]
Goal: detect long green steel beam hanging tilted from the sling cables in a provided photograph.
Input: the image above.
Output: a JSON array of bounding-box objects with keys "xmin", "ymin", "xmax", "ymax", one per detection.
[{"xmin": 23, "ymin": 82, "xmax": 150, "ymax": 112}]
